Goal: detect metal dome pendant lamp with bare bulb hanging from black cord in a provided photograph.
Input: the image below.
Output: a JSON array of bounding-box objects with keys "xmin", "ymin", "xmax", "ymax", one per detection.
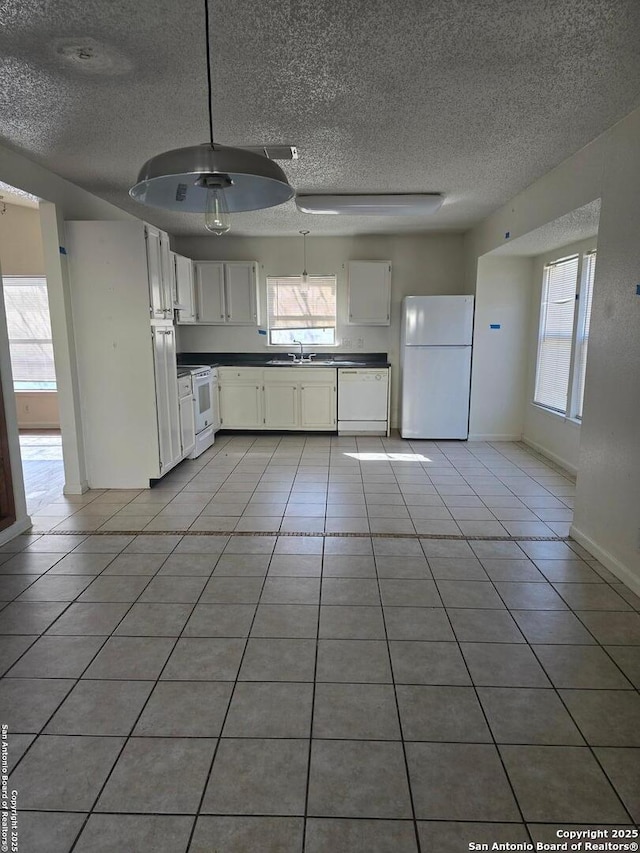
[{"xmin": 129, "ymin": 0, "xmax": 294, "ymax": 235}]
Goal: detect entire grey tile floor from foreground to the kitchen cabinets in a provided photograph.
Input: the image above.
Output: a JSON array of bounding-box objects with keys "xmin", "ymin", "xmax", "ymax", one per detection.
[{"xmin": 0, "ymin": 436, "xmax": 640, "ymax": 853}]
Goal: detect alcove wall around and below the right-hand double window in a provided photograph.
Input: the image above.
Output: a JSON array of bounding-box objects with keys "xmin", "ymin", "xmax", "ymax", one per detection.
[{"xmin": 523, "ymin": 237, "xmax": 597, "ymax": 474}]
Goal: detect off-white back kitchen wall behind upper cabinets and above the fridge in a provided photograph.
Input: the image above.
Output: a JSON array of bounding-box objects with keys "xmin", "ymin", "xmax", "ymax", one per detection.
[{"xmin": 172, "ymin": 233, "xmax": 465, "ymax": 426}]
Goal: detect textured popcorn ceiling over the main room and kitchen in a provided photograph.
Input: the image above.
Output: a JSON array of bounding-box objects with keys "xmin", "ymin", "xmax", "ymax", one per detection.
[{"xmin": 0, "ymin": 0, "xmax": 640, "ymax": 236}]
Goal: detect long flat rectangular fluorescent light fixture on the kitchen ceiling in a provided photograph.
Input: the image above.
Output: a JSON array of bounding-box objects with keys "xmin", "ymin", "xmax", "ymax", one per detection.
[{"xmin": 296, "ymin": 193, "xmax": 444, "ymax": 216}]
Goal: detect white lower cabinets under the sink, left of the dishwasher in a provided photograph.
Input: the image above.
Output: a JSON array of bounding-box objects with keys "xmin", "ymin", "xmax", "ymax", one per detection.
[{"xmin": 219, "ymin": 367, "xmax": 337, "ymax": 431}]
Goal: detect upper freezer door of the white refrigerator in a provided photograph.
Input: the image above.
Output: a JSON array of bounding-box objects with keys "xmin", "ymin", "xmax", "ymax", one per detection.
[{"xmin": 402, "ymin": 296, "xmax": 473, "ymax": 346}]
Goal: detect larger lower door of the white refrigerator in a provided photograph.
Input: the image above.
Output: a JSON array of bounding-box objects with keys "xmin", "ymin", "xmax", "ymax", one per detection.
[{"xmin": 400, "ymin": 347, "xmax": 471, "ymax": 439}]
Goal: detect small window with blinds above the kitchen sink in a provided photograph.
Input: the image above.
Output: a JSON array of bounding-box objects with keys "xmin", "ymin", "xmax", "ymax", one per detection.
[{"xmin": 267, "ymin": 275, "xmax": 337, "ymax": 346}]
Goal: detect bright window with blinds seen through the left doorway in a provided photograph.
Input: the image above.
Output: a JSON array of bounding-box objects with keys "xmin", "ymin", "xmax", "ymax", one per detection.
[{"xmin": 2, "ymin": 276, "xmax": 56, "ymax": 391}]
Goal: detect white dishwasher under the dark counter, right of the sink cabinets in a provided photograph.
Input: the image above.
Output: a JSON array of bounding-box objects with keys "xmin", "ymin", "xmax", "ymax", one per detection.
[{"xmin": 338, "ymin": 367, "xmax": 389, "ymax": 435}]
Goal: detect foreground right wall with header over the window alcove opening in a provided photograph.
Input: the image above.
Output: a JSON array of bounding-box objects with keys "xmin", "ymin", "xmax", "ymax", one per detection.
[{"xmin": 466, "ymin": 110, "xmax": 640, "ymax": 592}]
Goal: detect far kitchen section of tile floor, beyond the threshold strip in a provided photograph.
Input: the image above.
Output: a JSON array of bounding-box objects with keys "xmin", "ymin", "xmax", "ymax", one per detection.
[{"xmin": 32, "ymin": 434, "xmax": 575, "ymax": 537}]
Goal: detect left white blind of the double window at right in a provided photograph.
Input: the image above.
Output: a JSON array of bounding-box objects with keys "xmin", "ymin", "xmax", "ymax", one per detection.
[{"xmin": 534, "ymin": 256, "xmax": 579, "ymax": 414}]
